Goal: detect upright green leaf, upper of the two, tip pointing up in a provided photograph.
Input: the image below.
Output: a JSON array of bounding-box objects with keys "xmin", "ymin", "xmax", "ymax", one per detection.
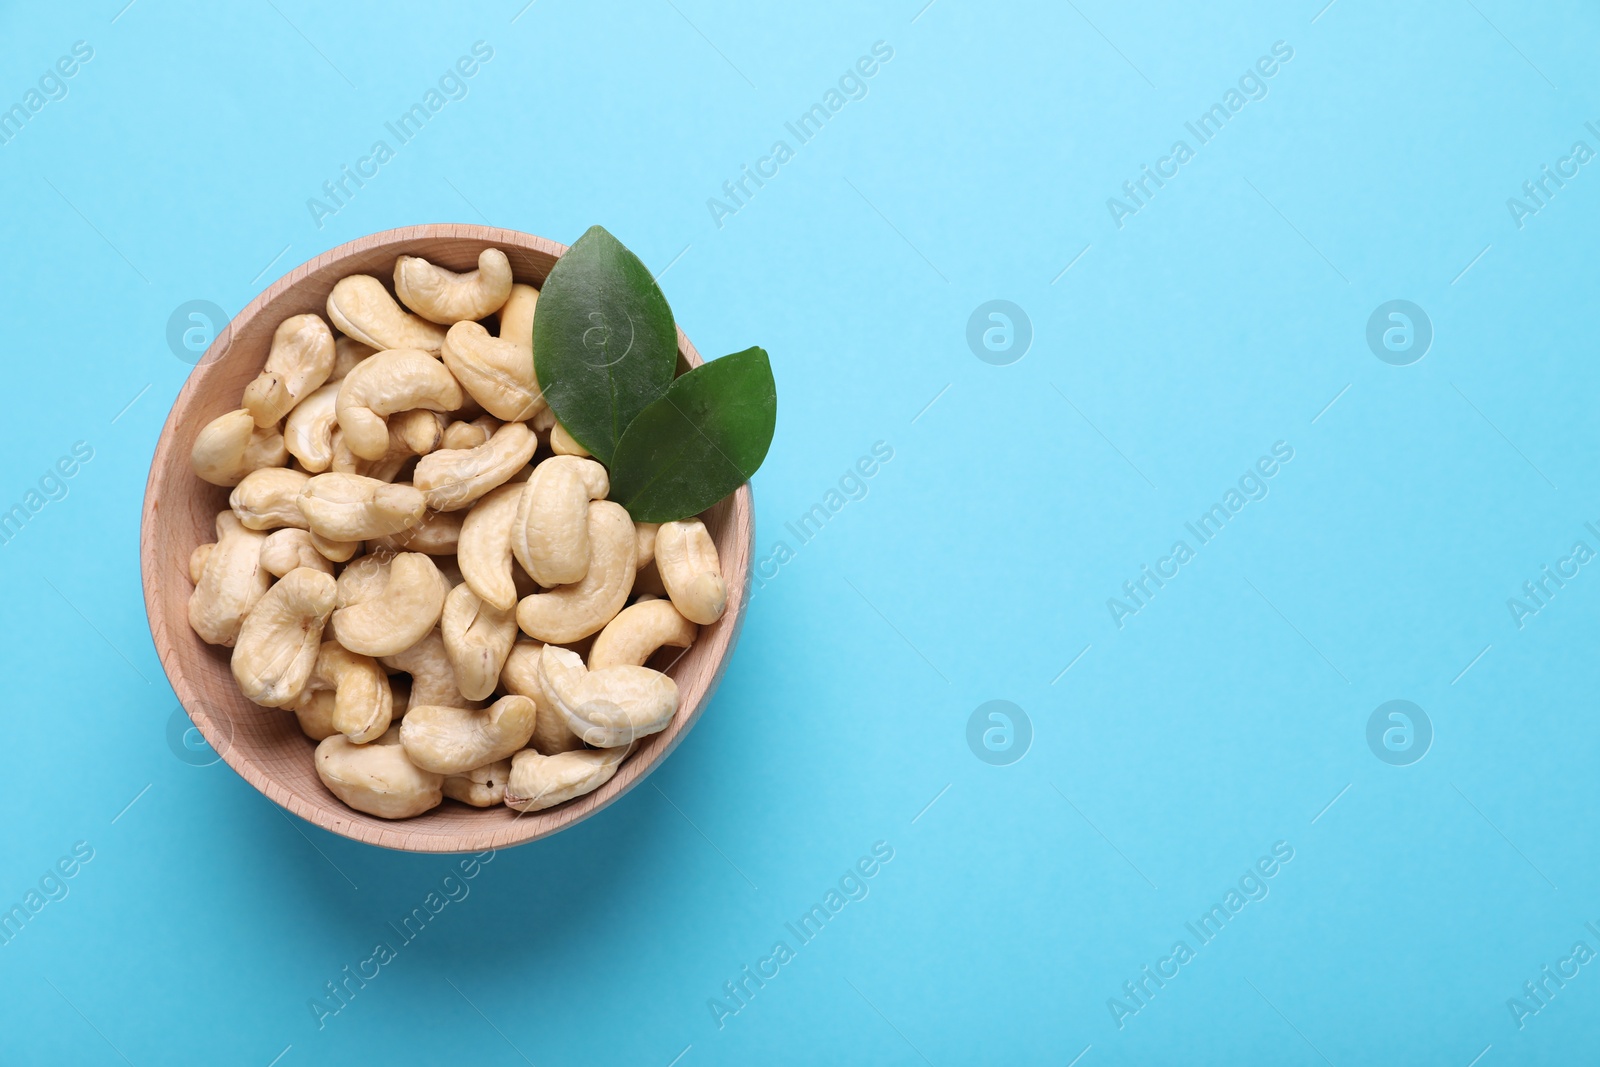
[{"xmin": 533, "ymin": 226, "xmax": 678, "ymax": 466}]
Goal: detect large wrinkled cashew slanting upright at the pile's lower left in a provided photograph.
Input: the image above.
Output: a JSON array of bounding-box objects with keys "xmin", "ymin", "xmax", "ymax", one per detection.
[{"xmin": 234, "ymin": 566, "xmax": 334, "ymax": 707}]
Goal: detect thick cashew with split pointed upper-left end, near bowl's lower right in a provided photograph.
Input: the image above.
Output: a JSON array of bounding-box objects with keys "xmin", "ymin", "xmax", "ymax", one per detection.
[{"xmin": 539, "ymin": 645, "xmax": 678, "ymax": 749}]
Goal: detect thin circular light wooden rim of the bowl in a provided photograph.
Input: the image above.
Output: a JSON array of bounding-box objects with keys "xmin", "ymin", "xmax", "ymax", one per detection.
[{"xmin": 139, "ymin": 222, "xmax": 755, "ymax": 854}]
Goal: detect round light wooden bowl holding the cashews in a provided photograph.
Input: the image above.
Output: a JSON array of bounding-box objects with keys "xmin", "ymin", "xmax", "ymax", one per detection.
[{"xmin": 139, "ymin": 226, "xmax": 754, "ymax": 853}]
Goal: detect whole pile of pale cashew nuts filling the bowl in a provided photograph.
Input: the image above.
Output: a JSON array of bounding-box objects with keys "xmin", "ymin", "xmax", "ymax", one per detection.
[{"xmin": 189, "ymin": 248, "xmax": 728, "ymax": 819}]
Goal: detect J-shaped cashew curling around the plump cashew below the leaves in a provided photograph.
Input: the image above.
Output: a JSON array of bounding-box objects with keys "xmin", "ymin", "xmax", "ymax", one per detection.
[{"xmin": 517, "ymin": 501, "xmax": 638, "ymax": 641}]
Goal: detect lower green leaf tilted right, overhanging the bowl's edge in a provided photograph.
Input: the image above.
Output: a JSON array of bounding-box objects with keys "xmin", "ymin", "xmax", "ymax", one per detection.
[{"xmin": 608, "ymin": 349, "xmax": 778, "ymax": 523}]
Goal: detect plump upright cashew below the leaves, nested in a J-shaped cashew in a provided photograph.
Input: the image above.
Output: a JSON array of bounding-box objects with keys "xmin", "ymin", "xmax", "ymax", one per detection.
[{"xmin": 510, "ymin": 456, "xmax": 611, "ymax": 585}]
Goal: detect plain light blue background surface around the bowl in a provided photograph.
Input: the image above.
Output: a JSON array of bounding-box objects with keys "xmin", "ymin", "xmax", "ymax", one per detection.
[{"xmin": 0, "ymin": 0, "xmax": 1600, "ymax": 1067}]
